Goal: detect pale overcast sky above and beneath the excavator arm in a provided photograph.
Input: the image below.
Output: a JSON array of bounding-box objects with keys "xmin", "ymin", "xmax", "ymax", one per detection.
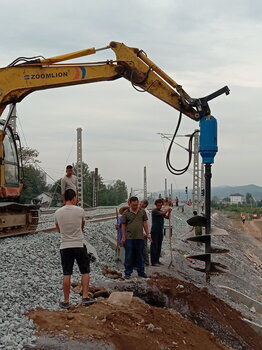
[{"xmin": 0, "ymin": 0, "xmax": 262, "ymax": 191}]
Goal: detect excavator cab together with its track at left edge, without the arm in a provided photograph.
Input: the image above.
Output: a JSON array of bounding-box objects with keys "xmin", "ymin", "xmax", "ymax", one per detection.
[{"xmin": 0, "ymin": 121, "xmax": 38, "ymax": 238}]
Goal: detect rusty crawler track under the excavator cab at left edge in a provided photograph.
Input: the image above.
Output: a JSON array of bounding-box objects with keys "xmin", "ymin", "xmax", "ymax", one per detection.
[{"xmin": 0, "ymin": 202, "xmax": 39, "ymax": 238}]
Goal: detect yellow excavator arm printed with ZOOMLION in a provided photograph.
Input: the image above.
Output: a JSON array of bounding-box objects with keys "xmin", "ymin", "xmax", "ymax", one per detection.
[{"xmin": 0, "ymin": 41, "xmax": 199, "ymax": 120}]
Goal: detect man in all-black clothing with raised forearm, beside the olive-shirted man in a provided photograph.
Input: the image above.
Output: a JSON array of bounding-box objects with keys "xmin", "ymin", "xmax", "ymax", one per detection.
[{"xmin": 150, "ymin": 199, "xmax": 172, "ymax": 266}]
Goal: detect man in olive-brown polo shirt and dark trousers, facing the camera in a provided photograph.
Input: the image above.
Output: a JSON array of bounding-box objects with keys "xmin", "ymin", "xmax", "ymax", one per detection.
[{"xmin": 122, "ymin": 197, "xmax": 150, "ymax": 279}]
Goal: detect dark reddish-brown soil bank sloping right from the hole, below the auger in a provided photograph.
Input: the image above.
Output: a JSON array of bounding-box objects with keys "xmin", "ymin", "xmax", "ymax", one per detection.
[{"xmin": 148, "ymin": 274, "xmax": 262, "ymax": 350}]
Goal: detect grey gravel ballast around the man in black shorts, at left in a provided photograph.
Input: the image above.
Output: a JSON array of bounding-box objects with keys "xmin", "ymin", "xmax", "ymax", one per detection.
[{"xmin": 0, "ymin": 211, "xmax": 116, "ymax": 350}]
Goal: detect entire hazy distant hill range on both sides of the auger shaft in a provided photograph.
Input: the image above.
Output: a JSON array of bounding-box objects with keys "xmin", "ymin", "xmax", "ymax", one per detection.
[{"xmin": 154, "ymin": 185, "xmax": 262, "ymax": 200}]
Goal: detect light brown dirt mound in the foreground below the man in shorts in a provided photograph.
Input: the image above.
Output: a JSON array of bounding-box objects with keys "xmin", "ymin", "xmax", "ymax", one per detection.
[{"xmin": 27, "ymin": 298, "xmax": 228, "ymax": 350}]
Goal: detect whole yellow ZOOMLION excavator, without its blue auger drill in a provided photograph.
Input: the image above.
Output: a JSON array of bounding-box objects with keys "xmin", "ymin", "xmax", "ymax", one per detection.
[{"xmin": 0, "ymin": 41, "xmax": 229, "ymax": 237}]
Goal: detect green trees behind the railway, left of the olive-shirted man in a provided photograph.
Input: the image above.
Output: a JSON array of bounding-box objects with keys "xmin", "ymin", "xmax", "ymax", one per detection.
[{"xmin": 20, "ymin": 147, "xmax": 128, "ymax": 207}]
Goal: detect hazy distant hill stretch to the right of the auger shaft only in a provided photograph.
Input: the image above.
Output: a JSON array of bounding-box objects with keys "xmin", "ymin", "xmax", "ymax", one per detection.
[{"xmin": 212, "ymin": 185, "xmax": 262, "ymax": 200}]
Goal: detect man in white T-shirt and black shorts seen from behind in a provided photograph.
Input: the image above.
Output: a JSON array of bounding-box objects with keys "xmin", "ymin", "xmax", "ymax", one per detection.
[{"xmin": 55, "ymin": 188, "xmax": 94, "ymax": 309}]
